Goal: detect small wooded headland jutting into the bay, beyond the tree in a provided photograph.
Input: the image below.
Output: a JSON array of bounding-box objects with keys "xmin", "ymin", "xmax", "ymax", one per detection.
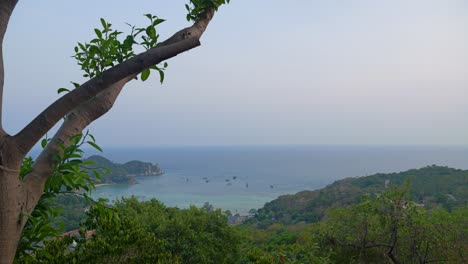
[{"xmin": 87, "ymin": 155, "xmax": 164, "ymax": 185}]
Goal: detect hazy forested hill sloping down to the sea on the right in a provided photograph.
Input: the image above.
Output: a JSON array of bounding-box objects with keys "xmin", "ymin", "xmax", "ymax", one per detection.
[{"xmin": 253, "ymin": 165, "xmax": 468, "ymax": 226}]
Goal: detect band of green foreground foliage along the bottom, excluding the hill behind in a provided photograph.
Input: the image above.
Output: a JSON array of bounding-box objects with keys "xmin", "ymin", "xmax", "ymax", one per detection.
[{"xmin": 22, "ymin": 176, "xmax": 468, "ymax": 264}]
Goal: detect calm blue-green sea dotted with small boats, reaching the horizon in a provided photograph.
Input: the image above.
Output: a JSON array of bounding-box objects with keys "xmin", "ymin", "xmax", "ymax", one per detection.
[{"xmin": 88, "ymin": 146, "xmax": 468, "ymax": 214}]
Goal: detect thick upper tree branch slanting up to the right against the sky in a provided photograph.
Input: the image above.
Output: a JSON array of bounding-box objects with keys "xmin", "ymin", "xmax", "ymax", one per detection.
[{"xmin": 14, "ymin": 10, "xmax": 218, "ymax": 155}]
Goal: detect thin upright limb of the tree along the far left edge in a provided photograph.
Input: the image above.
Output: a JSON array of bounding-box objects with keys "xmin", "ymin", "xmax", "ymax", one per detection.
[{"xmin": 0, "ymin": 0, "xmax": 18, "ymax": 132}]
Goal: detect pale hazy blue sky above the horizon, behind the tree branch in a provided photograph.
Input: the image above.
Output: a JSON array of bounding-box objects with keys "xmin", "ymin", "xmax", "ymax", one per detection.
[{"xmin": 3, "ymin": 0, "xmax": 468, "ymax": 146}]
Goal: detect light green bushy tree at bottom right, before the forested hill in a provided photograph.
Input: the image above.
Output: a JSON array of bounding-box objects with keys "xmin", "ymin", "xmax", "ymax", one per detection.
[{"xmin": 321, "ymin": 187, "xmax": 468, "ymax": 263}]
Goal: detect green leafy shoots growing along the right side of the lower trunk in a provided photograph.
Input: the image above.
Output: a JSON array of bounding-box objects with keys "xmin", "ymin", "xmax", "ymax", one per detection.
[{"xmin": 16, "ymin": 132, "xmax": 108, "ymax": 262}]
